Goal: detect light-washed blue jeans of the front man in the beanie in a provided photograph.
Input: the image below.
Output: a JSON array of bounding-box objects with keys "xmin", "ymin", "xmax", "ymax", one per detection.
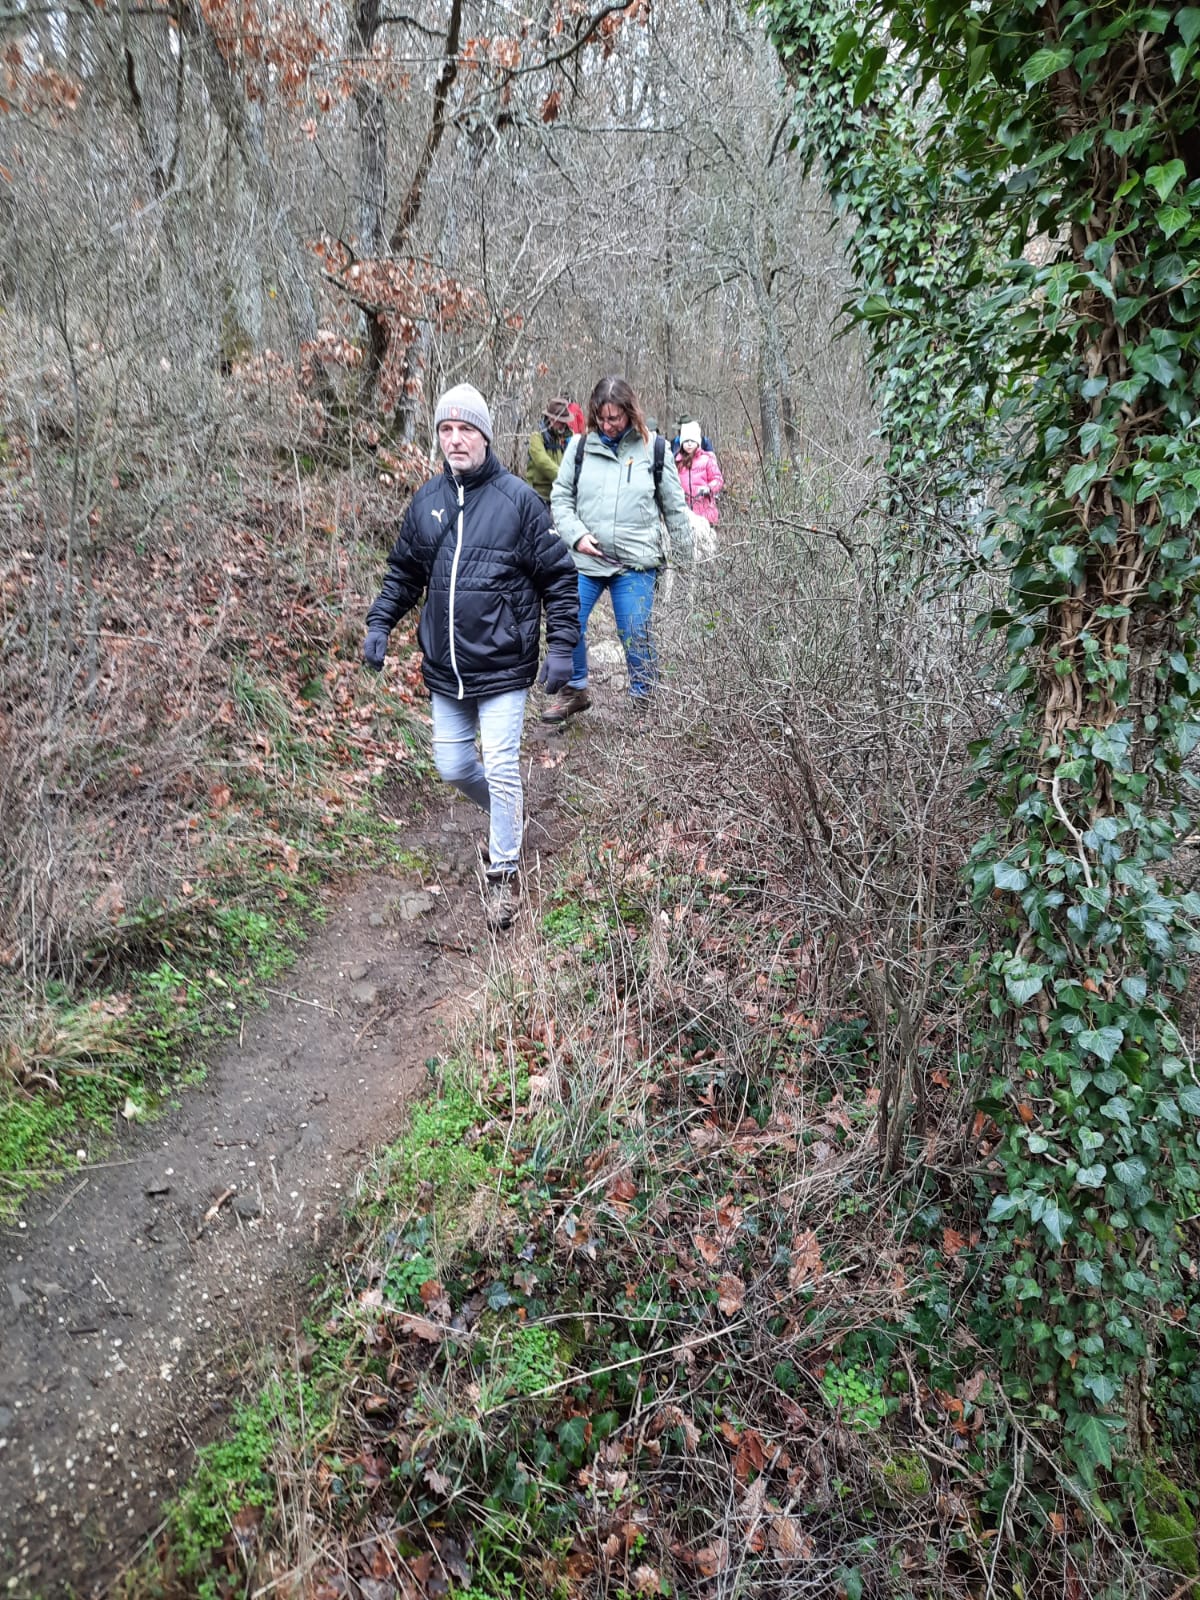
[{"xmin": 430, "ymin": 690, "xmax": 528, "ymax": 875}]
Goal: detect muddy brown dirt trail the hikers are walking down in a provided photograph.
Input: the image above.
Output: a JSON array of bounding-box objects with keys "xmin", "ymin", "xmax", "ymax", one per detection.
[{"xmin": 0, "ymin": 718, "xmax": 582, "ymax": 1600}]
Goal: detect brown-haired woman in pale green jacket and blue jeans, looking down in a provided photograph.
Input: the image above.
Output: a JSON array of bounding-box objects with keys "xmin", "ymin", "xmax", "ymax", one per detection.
[{"xmin": 542, "ymin": 378, "xmax": 691, "ymax": 722}]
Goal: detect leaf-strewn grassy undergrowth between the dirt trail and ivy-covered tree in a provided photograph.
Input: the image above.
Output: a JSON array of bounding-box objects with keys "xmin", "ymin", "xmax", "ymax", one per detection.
[{"xmin": 136, "ymin": 819, "xmax": 1194, "ymax": 1600}]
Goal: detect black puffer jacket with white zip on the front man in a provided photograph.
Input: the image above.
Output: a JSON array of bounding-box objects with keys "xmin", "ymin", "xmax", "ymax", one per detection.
[{"xmin": 366, "ymin": 450, "xmax": 579, "ymax": 699}]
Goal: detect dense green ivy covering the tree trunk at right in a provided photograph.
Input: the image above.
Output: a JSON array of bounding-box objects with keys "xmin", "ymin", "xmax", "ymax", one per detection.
[{"xmin": 760, "ymin": 0, "xmax": 1200, "ymax": 1491}]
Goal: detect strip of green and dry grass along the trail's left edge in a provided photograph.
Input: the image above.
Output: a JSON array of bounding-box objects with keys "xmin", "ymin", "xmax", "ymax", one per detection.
[{"xmin": 0, "ymin": 691, "xmax": 422, "ymax": 1221}]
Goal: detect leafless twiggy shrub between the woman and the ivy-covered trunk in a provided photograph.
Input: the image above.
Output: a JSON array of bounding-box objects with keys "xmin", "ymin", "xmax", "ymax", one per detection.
[{"xmin": 569, "ymin": 454, "xmax": 995, "ymax": 1174}]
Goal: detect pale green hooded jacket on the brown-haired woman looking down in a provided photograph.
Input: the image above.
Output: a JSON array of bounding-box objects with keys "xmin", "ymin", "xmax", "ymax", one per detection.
[{"xmin": 550, "ymin": 429, "xmax": 691, "ymax": 578}]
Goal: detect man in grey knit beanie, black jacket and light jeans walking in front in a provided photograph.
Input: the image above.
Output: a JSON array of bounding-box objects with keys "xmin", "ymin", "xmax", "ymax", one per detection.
[{"xmin": 363, "ymin": 384, "xmax": 579, "ymax": 928}]
